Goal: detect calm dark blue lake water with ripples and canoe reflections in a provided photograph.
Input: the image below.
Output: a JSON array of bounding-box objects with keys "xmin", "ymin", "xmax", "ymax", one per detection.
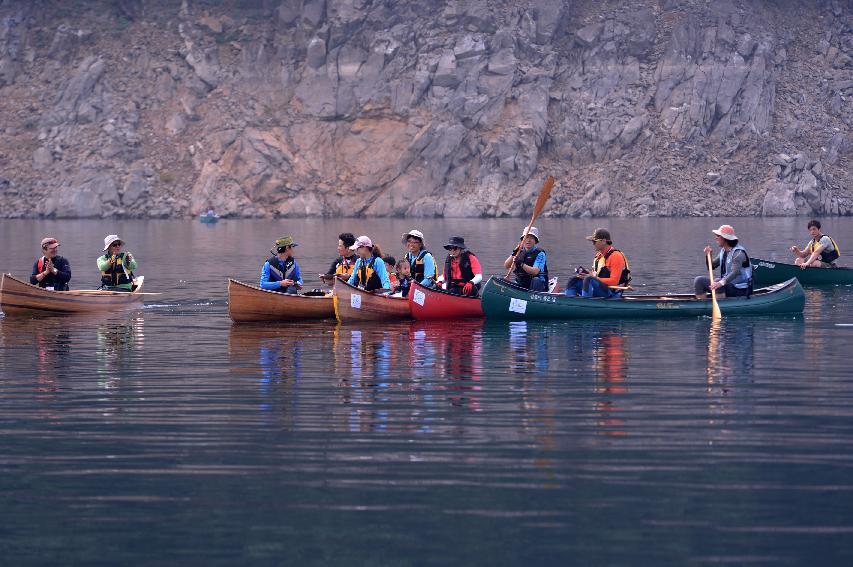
[{"xmin": 0, "ymin": 219, "xmax": 853, "ymax": 566}]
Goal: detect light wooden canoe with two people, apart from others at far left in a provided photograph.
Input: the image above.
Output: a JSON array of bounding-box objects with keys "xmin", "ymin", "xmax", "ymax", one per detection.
[{"xmin": 0, "ymin": 274, "xmax": 145, "ymax": 316}]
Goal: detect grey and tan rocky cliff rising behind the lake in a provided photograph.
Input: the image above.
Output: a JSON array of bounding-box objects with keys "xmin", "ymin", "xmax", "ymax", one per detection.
[{"xmin": 0, "ymin": 0, "xmax": 853, "ymax": 217}]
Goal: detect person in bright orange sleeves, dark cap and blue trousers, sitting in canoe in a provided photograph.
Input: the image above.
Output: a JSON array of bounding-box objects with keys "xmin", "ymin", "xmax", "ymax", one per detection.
[{"xmin": 565, "ymin": 228, "xmax": 631, "ymax": 298}]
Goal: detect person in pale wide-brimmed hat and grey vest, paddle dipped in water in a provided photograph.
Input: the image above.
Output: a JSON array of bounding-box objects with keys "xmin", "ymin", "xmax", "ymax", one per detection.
[{"xmin": 693, "ymin": 224, "xmax": 752, "ymax": 299}]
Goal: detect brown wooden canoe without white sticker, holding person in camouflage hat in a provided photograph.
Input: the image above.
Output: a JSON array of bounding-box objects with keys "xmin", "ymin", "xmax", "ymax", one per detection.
[{"xmin": 228, "ymin": 278, "xmax": 335, "ymax": 323}]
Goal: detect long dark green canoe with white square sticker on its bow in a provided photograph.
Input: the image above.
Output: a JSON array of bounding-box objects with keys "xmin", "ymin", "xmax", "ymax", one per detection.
[{"xmin": 480, "ymin": 277, "xmax": 806, "ymax": 319}]
